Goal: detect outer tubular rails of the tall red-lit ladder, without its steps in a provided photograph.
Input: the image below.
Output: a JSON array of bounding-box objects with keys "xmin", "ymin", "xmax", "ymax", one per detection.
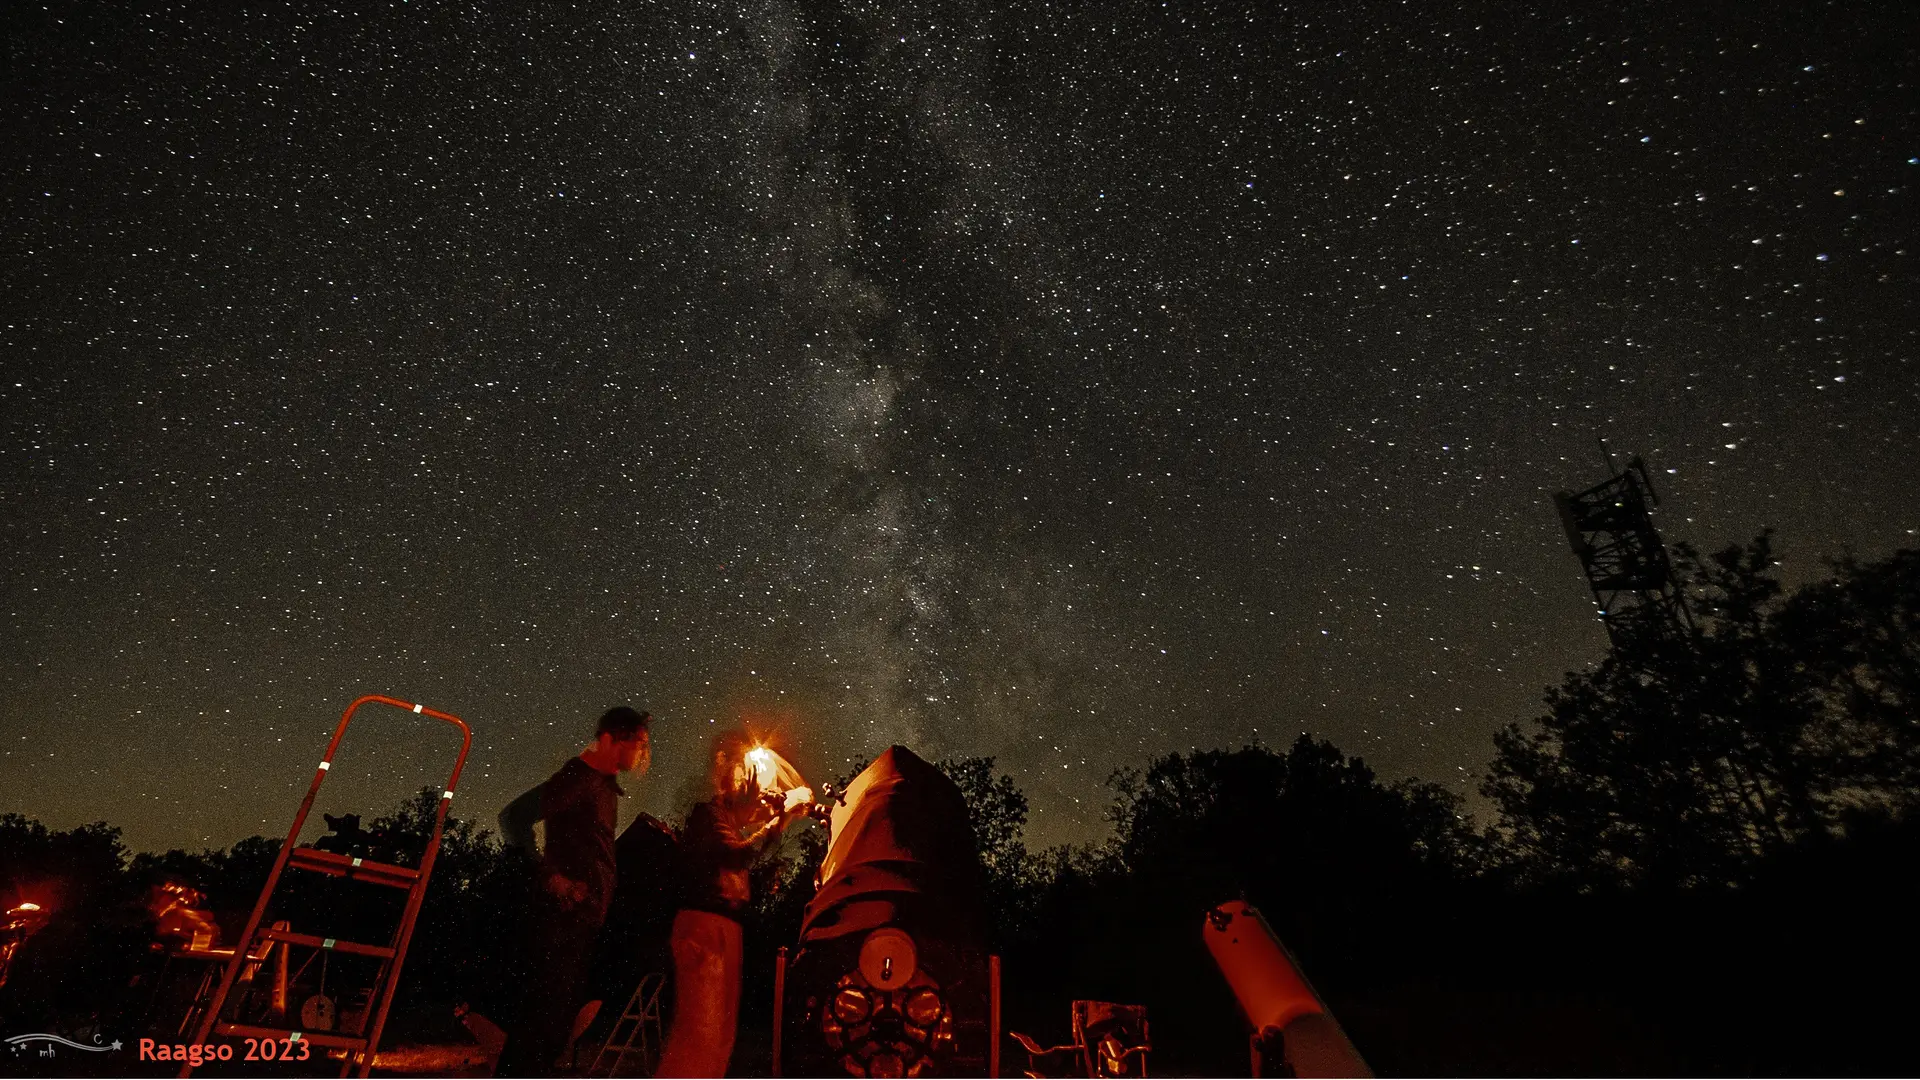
[{"xmin": 179, "ymin": 694, "xmax": 474, "ymax": 1078}]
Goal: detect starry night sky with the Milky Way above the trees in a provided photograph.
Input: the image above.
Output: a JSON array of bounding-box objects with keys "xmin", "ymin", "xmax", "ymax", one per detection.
[{"xmin": 0, "ymin": 0, "xmax": 1920, "ymax": 847}]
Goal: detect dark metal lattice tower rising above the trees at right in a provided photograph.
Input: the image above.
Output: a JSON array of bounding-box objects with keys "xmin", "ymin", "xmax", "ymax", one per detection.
[{"xmin": 1553, "ymin": 457, "xmax": 1693, "ymax": 648}]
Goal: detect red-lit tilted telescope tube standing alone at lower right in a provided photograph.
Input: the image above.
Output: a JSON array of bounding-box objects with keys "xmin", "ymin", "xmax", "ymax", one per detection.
[{"xmin": 1200, "ymin": 901, "xmax": 1373, "ymax": 1076}]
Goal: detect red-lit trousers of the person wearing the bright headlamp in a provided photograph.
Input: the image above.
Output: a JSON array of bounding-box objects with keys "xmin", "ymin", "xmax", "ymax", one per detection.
[{"xmin": 653, "ymin": 911, "xmax": 741, "ymax": 1076}]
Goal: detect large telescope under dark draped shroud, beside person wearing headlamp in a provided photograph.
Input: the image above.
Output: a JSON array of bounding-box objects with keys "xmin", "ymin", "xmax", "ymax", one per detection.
[{"xmin": 781, "ymin": 746, "xmax": 989, "ymax": 1076}]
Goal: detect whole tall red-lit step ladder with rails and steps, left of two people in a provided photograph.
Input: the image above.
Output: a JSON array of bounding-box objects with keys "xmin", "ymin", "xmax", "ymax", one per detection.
[{"xmin": 180, "ymin": 694, "xmax": 474, "ymax": 1078}]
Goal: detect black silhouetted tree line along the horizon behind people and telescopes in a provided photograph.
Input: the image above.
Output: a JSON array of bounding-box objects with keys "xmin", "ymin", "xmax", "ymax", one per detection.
[{"xmin": 0, "ymin": 534, "xmax": 1920, "ymax": 1074}]
